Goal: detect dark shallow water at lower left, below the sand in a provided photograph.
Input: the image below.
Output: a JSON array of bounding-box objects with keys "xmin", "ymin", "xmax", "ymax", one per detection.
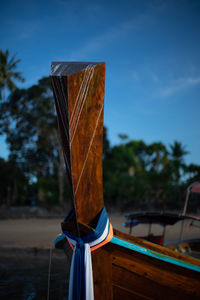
[{"xmin": 0, "ymin": 251, "xmax": 69, "ymax": 300}]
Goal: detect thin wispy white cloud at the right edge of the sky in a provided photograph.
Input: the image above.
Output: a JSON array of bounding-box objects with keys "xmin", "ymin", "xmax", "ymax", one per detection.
[{"xmin": 160, "ymin": 77, "xmax": 200, "ymax": 97}]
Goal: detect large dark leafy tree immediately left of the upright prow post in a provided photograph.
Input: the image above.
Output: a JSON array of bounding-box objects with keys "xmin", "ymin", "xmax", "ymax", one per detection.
[{"xmin": 0, "ymin": 77, "xmax": 65, "ymax": 204}]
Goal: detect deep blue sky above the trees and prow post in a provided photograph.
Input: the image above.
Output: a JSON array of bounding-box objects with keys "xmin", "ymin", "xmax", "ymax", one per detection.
[{"xmin": 0, "ymin": 0, "xmax": 200, "ymax": 164}]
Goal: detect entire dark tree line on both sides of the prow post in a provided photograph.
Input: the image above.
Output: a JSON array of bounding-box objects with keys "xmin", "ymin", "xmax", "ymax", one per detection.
[{"xmin": 0, "ymin": 51, "xmax": 200, "ymax": 209}]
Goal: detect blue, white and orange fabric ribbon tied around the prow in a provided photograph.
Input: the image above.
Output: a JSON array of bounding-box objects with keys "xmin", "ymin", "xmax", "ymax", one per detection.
[{"xmin": 63, "ymin": 207, "xmax": 113, "ymax": 300}]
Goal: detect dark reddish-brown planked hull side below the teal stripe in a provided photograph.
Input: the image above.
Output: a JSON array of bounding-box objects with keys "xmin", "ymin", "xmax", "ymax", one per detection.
[{"xmin": 103, "ymin": 239, "xmax": 200, "ymax": 299}]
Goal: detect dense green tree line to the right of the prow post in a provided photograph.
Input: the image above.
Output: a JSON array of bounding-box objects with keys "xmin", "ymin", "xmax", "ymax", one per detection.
[{"xmin": 103, "ymin": 135, "xmax": 200, "ymax": 210}]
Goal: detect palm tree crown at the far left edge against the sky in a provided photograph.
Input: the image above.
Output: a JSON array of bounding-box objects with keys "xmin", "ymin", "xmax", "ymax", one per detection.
[{"xmin": 0, "ymin": 49, "xmax": 24, "ymax": 102}]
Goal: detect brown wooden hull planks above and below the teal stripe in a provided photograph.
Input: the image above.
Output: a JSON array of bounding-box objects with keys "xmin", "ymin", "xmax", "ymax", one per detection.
[{"xmin": 93, "ymin": 234, "xmax": 200, "ymax": 300}]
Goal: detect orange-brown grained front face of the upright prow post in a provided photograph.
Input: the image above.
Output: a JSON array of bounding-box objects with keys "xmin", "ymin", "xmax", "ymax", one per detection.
[{"xmin": 68, "ymin": 64, "xmax": 105, "ymax": 224}]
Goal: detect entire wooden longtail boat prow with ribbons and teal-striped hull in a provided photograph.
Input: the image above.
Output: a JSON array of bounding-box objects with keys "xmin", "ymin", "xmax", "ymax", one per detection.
[{"xmin": 51, "ymin": 62, "xmax": 200, "ymax": 300}]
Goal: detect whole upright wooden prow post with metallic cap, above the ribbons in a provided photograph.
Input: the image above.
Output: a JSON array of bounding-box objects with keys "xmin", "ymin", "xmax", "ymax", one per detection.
[{"xmin": 51, "ymin": 63, "xmax": 105, "ymax": 230}]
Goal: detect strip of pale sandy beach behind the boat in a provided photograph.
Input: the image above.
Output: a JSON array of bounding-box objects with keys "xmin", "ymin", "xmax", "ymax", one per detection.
[{"xmin": 0, "ymin": 215, "xmax": 200, "ymax": 249}]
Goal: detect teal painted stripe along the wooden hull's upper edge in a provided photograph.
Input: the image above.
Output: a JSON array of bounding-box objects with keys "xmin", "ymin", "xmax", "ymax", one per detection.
[{"xmin": 111, "ymin": 237, "xmax": 200, "ymax": 272}]
